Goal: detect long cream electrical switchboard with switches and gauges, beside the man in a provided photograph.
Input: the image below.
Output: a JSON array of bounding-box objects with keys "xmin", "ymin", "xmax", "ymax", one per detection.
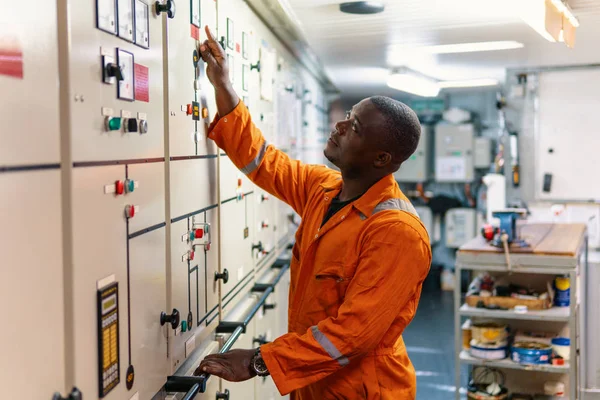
[{"xmin": 0, "ymin": 0, "xmax": 327, "ymax": 400}]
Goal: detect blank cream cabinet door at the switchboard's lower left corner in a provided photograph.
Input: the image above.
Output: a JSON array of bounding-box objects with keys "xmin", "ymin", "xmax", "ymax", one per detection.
[{"xmin": 0, "ymin": 170, "xmax": 64, "ymax": 399}]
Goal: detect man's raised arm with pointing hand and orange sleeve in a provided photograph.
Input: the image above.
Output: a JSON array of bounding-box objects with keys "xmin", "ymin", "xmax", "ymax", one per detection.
[{"xmin": 200, "ymin": 27, "xmax": 336, "ymax": 215}]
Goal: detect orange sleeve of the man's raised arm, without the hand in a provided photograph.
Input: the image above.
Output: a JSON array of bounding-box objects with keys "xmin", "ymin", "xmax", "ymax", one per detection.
[{"xmin": 208, "ymin": 101, "xmax": 336, "ymax": 216}]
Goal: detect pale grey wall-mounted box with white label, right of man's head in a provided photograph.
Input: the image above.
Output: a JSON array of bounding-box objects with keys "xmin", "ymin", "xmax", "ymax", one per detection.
[{"xmin": 435, "ymin": 124, "xmax": 475, "ymax": 182}]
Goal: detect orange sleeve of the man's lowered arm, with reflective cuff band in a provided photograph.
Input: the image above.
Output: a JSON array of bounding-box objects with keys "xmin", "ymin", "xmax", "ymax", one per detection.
[{"xmin": 261, "ymin": 222, "xmax": 431, "ymax": 395}]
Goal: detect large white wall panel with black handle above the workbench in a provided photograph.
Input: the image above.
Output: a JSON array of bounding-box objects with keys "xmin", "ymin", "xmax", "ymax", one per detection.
[{"xmin": 535, "ymin": 68, "xmax": 600, "ymax": 200}]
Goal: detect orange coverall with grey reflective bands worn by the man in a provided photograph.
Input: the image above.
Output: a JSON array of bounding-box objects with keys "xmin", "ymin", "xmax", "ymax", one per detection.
[{"xmin": 209, "ymin": 101, "xmax": 431, "ymax": 400}]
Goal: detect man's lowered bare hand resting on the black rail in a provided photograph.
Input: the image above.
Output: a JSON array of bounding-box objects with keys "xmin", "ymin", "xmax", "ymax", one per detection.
[{"xmin": 194, "ymin": 350, "xmax": 256, "ymax": 382}]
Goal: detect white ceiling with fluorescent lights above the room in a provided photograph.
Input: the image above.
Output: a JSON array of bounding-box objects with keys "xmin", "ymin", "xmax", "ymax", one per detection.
[{"xmin": 280, "ymin": 0, "xmax": 600, "ymax": 97}]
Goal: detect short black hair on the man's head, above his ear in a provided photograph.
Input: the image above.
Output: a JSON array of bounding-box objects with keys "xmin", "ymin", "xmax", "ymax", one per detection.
[{"xmin": 369, "ymin": 96, "xmax": 421, "ymax": 167}]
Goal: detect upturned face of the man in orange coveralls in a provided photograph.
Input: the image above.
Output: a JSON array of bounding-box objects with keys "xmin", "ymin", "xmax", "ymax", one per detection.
[{"xmin": 323, "ymin": 99, "xmax": 383, "ymax": 177}]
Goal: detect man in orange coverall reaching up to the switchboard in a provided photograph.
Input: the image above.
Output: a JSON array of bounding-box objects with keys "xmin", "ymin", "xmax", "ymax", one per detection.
[{"xmin": 195, "ymin": 27, "xmax": 431, "ymax": 400}]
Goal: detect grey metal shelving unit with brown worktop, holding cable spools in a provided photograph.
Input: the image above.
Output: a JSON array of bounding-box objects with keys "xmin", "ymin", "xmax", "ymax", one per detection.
[{"xmin": 454, "ymin": 224, "xmax": 587, "ymax": 400}]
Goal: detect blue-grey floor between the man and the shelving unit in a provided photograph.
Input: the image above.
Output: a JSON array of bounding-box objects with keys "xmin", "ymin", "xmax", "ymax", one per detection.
[{"xmin": 403, "ymin": 271, "xmax": 467, "ymax": 400}]
